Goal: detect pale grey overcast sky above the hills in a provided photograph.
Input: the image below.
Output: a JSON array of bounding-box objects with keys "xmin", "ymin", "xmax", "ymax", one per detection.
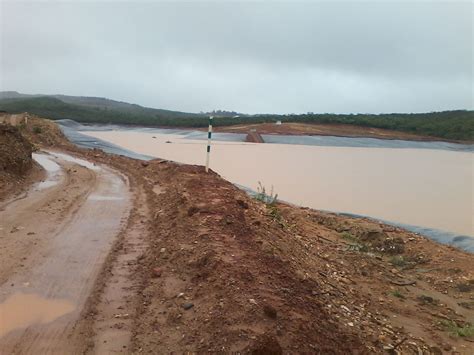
[{"xmin": 0, "ymin": 0, "xmax": 473, "ymax": 113}]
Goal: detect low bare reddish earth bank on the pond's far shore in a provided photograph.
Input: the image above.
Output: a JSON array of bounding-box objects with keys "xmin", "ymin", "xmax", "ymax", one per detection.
[{"xmin": 214, "ymin": 122, "xmax": 466, "ymax": 141}]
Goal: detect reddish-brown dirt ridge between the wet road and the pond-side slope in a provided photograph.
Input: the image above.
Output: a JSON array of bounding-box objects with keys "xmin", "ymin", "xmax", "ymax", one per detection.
[{"xmin": 137, "ymin": 165, "xmax": 366, "ymax": 353}]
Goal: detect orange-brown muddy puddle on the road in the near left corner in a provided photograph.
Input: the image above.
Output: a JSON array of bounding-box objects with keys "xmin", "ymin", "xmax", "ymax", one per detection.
[{"xmin": 0, "ymin": 293, "xmax": 75, "ymax": 337}]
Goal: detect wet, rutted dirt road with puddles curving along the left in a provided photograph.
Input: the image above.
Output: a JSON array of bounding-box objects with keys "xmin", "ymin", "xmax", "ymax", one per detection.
[{"xmin": 0, "ymin": 152, "xmax": 130, "ymax": 354}]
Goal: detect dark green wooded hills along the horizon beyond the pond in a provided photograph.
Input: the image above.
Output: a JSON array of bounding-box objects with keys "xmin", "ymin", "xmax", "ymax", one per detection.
[{"xmin": 0, "ymin": 96, "xmax": 474, "ymax": 141}]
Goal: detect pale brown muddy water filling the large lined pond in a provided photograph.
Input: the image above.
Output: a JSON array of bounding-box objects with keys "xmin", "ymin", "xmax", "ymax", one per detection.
[{"xmin": 82, "ymin": 131, "xmax": 474, "ymax": 236}]
